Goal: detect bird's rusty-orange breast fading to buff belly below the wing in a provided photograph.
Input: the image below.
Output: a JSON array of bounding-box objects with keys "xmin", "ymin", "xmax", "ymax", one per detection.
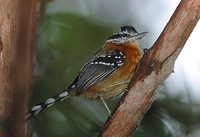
[{"xmin": 81, "ymin": 43, "xmax": 142, "ymax": 99}]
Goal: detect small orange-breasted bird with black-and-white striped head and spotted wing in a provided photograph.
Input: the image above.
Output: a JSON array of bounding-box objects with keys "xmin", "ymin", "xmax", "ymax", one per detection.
[{"xmin": 25, "ymin": 26, "xmax": 147, "ymax": 119}]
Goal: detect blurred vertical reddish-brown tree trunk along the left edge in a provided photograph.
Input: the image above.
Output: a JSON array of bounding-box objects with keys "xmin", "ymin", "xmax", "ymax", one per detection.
[{"xmin": 0, "ymin": 0, "xmax": 39, "ymax": 137}]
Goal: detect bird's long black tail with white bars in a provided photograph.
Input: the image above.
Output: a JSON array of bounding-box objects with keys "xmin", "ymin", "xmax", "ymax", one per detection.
[{"xmin": 25, "ymin": 91, "xmax": 69, "ymax": 121}]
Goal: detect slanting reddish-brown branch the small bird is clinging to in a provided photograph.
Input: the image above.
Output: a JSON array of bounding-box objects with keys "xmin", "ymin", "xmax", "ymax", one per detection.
[{"xmin": 99, "ymin": 0, "xmax": 200, "ymax": 137}]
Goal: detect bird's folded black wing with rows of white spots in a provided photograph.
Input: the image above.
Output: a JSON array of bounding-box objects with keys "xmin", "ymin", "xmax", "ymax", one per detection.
[{"xmin": 69, "ymin": 51, "xmax": 125, "ymax": 94}]
